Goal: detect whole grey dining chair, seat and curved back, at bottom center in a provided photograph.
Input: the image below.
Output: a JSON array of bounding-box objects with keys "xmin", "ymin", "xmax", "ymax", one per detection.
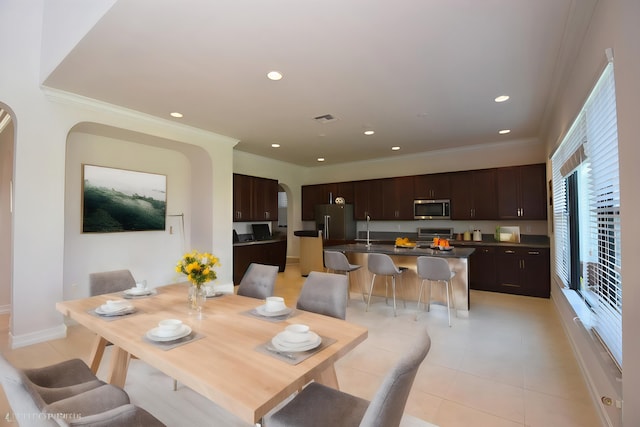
[{"xmin": 265, "ymin": 327, "xmax": 431, "ymax": 427}]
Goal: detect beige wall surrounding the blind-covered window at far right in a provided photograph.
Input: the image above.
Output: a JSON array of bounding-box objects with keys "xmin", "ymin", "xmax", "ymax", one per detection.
[{"xmin": 546, "ymin": 0, "xmax": 640, "ymax": 426}]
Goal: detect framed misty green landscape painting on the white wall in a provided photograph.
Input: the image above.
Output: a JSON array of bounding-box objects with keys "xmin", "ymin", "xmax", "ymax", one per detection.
[{"xmin": 82, "ymin": 165, "xmax": 167, "ymax": 233}]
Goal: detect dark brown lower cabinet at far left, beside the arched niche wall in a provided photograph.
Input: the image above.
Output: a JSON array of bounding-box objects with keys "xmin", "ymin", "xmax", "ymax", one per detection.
[{"xmin": 233, "ymin": 240, "xmax": 287, "ymax": 286}]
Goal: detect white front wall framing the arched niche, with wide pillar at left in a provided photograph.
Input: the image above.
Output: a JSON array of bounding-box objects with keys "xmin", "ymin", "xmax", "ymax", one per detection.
[{"xmin": 0, "ymin": 1, "xmax": 237, "ymax": 347}]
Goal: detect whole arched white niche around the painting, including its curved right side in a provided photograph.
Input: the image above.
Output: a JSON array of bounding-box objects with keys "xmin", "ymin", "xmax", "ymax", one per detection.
[{"xmin": 63, "ymin": 122, "xmax": 215, "ymax": 299}]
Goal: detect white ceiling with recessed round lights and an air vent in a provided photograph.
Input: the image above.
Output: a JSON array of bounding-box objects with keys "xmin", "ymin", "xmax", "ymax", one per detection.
[{"xmin": 45, "ymin": 0, "xmax": 596, "ymax": 166}]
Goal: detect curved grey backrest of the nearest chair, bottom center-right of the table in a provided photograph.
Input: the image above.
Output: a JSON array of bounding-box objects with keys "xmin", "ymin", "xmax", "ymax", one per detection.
[{"xmin": 360, "ymin": 328, "xmax": 431, "ymax": 427}]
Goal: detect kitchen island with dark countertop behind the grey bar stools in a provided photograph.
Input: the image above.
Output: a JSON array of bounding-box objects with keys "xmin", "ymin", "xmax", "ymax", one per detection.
[{"xmin": 324, "ymin": 243, "xmax": 474, "ymax": 317}]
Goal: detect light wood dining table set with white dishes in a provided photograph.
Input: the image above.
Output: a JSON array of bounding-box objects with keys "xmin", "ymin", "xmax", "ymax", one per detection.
[{"xmin": 56, "ymin": 283, "xmax": 367, "ymax": 424}]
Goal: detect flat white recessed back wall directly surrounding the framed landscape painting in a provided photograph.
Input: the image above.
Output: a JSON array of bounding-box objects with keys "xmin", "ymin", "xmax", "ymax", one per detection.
[{"xmin": 63, "ymin": 132, "xmax": 192, "ymax": 299}]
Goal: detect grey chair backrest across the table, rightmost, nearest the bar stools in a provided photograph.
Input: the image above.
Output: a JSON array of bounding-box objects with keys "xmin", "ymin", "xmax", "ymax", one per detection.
[{"xmin": 296, "ymin": 271, "xmax": 349, "ymax": 319}]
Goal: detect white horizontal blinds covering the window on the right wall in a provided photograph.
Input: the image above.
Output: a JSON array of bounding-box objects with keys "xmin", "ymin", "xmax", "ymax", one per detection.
[{"xmin": 551, "ymin": 63, "xmax": 622, "ymax": 367}]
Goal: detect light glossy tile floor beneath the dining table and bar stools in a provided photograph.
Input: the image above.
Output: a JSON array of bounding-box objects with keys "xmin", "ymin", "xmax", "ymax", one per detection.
[{"xmin": 0, "ymin": 264, "xmax": 601, "ymax": 427}]
